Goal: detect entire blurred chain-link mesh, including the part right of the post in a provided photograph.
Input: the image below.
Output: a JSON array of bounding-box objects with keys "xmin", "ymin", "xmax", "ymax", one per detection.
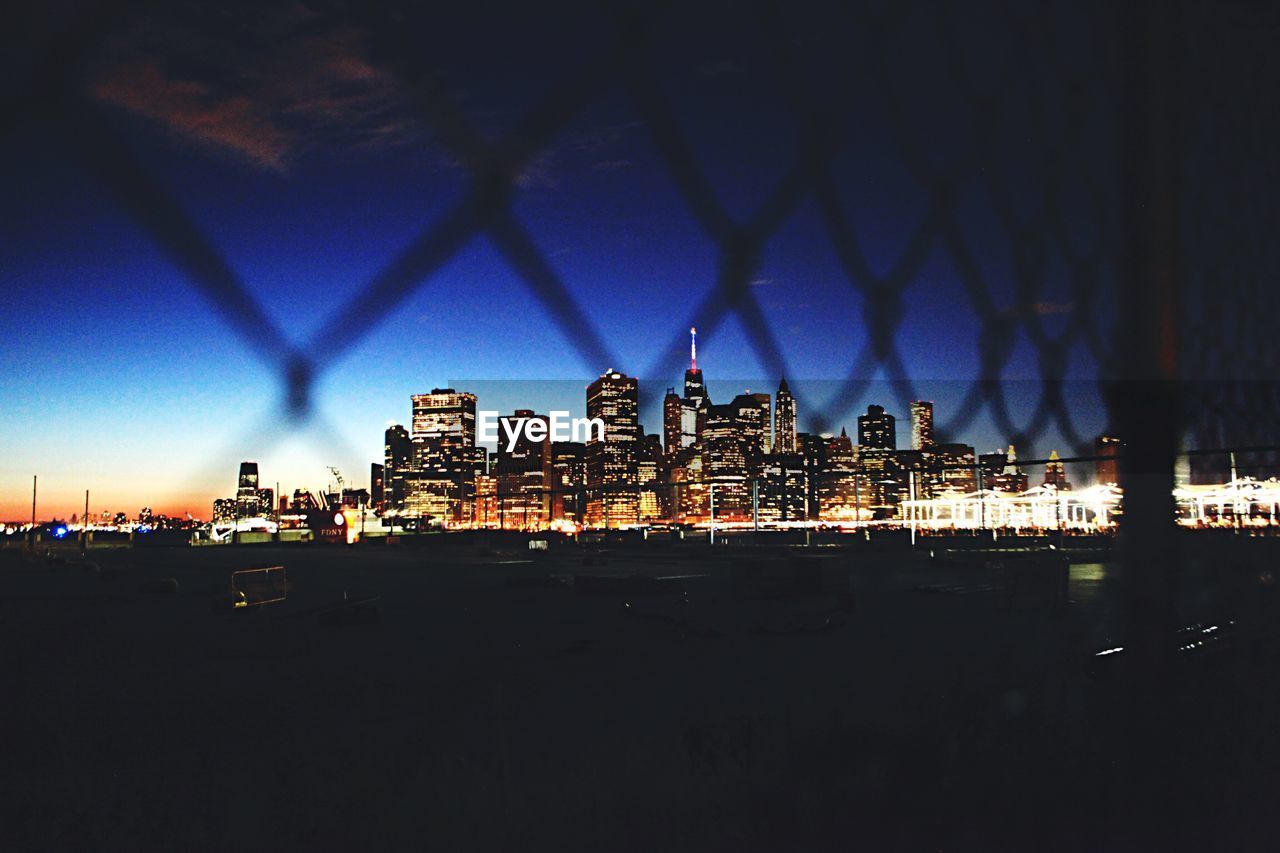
[{"xmin": 5, "ymin": 0, "xmax": 1280, "ymax": 517}]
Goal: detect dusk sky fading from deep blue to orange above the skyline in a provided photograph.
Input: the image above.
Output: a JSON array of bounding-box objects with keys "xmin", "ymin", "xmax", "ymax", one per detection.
[{"xmin": 0, "ymin": 3, "xmax": 1110, "ymax": 520}]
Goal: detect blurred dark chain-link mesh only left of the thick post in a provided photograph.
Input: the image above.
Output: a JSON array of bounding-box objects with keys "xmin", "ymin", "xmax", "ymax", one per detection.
[{"xmin": 8, "ymin": 3, "xmax": 1120, "ymax": 452}]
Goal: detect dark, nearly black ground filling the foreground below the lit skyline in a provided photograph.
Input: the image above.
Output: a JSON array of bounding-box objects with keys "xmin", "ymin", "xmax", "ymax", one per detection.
[{"xmin": 0, "ymin": 539, "xmax": 1280, "ymax": 850}]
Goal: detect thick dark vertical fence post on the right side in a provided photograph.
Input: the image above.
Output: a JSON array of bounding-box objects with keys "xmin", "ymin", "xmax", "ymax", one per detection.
[{"xmin": 1107, "ymin": 0, "xmax": 1183, "ymax": 826}]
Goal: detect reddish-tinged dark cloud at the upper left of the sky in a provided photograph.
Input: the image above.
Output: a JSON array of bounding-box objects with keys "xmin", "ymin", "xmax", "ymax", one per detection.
[{"xmin": 90, "ymin": 6, "xmax": 425, "ymax": 172}]
